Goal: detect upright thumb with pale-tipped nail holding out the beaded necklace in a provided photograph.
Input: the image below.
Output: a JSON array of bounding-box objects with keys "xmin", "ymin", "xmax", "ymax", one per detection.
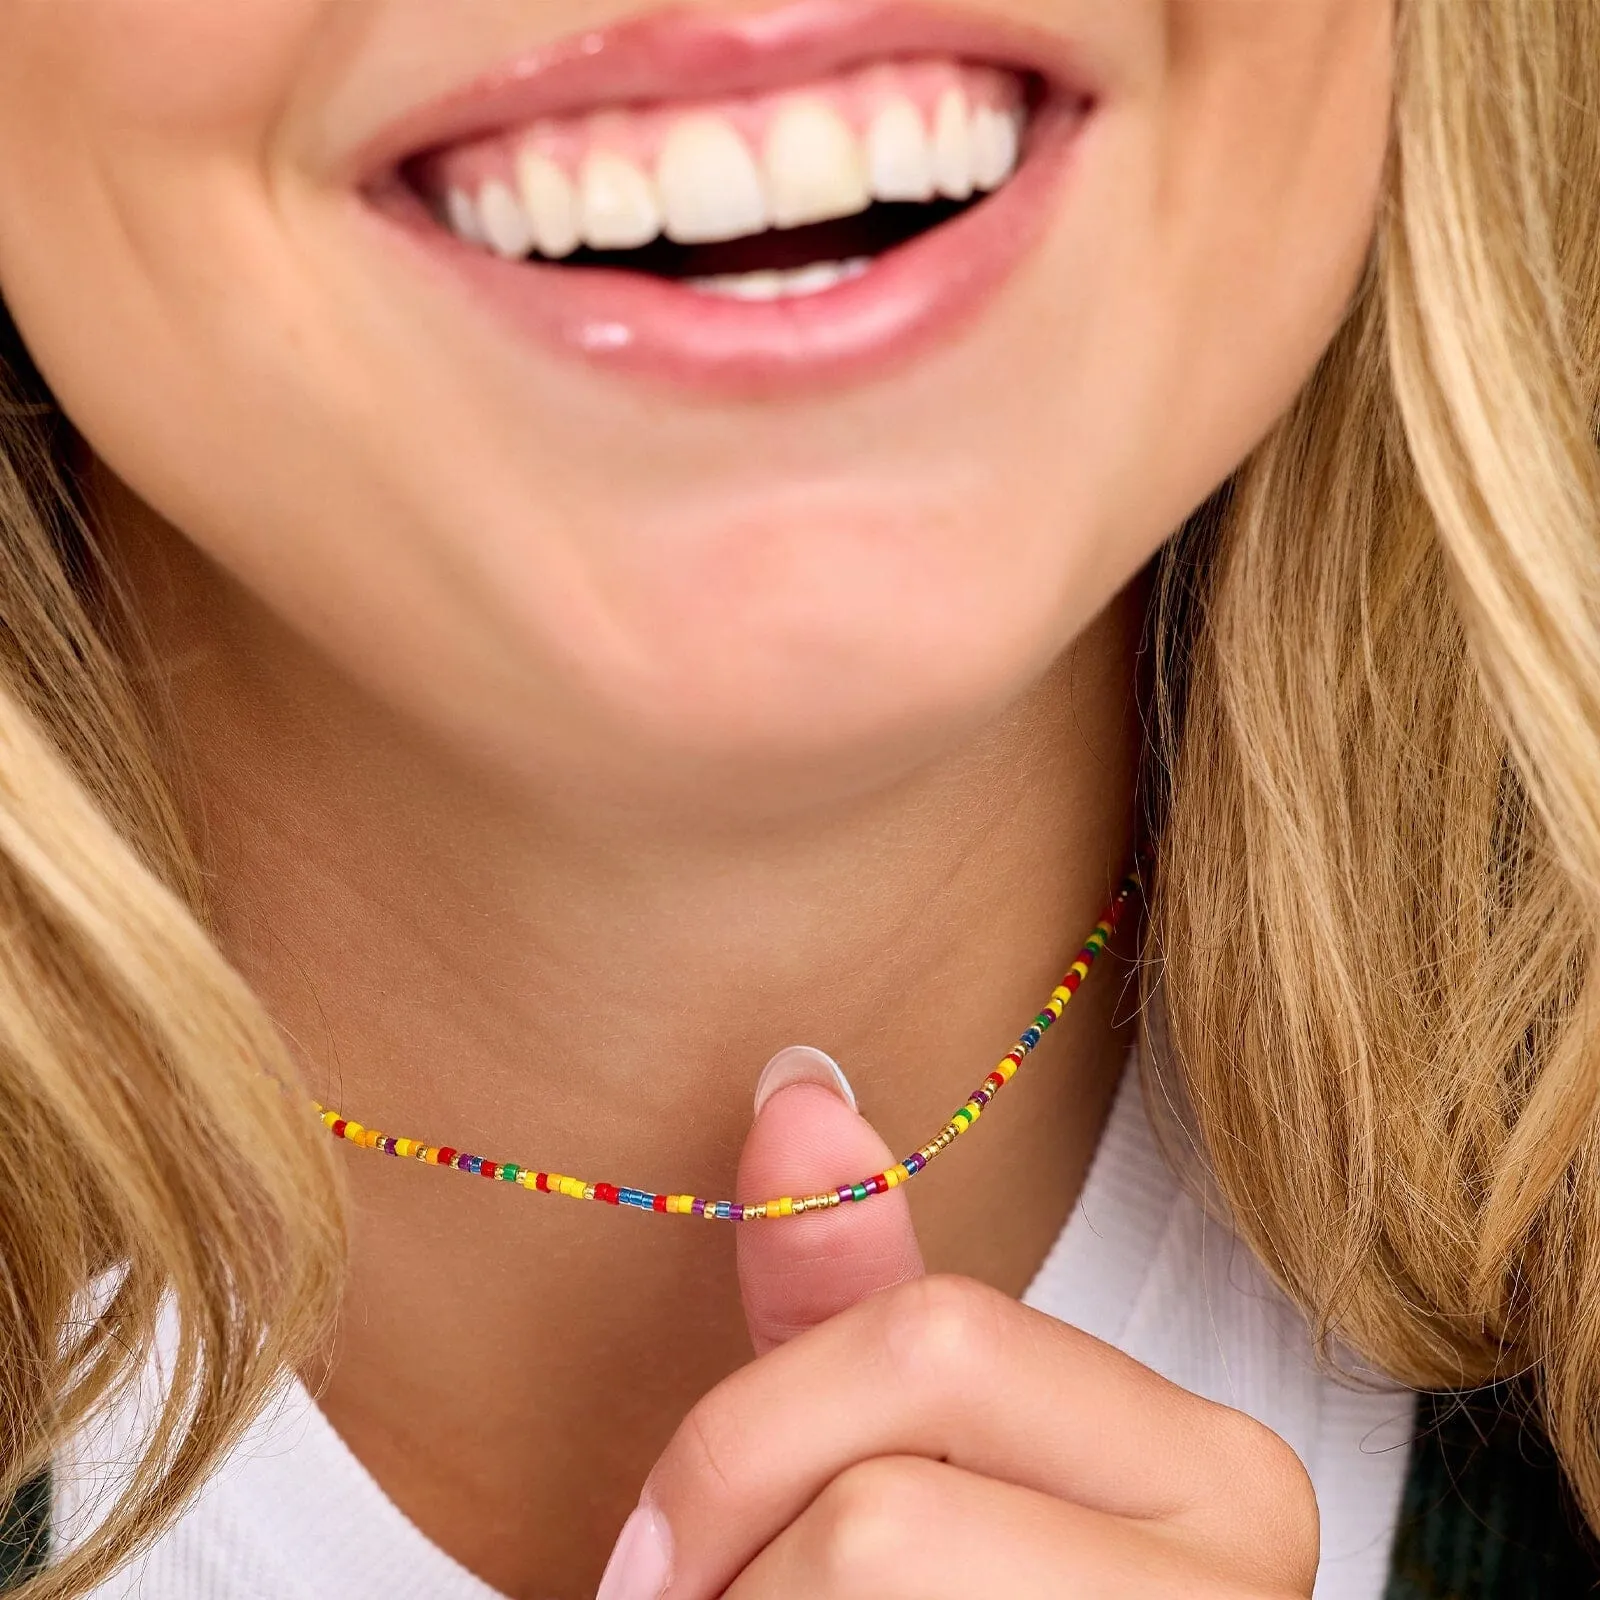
[{"xmin": 736, "ymin": 1045, "xmax": 923, "ymax": 1355}]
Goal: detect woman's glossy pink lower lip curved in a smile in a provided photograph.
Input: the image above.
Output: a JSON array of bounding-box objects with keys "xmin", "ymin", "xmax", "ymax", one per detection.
[{"xmin": 371, "ymin": 102, "xmax": 1090, "ymax": 397}]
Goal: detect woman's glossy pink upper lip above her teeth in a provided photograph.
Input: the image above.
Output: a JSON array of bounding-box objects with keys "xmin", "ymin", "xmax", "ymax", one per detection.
[{"xmin": 355, "ymin": 0, "xmax": 1096, "ymax": 181}]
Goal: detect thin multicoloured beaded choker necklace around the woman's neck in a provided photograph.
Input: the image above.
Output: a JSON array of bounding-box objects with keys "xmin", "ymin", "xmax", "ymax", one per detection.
[{"xmin": 317, "ymin": 874, "xmax": 1139, "ymax": 1222}]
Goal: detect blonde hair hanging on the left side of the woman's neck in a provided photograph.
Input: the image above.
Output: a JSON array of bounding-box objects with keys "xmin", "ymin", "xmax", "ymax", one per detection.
[{"xmin": 0, "ymin": 331, "xmax": 342, "ymax": 1597}]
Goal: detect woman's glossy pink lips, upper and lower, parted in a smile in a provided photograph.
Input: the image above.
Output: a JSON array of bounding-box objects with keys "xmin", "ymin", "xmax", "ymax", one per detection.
[{"xmin": 355, "ymin": 0, "xmax": 1099, "ymax": 395}]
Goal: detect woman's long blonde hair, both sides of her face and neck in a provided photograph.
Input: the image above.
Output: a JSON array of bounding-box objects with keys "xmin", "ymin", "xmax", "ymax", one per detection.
[{"xmin": 0, "ymin": 0, "xmax": 1600, "ymax": 1600}]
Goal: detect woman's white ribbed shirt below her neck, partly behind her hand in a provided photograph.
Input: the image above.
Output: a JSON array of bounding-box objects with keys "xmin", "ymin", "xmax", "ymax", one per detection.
[{"xmin": 65, "ymin": 1072, "xmax": 1413, "ymax": 1600}]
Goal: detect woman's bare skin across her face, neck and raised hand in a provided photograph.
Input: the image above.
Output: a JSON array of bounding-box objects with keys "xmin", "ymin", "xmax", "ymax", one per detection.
[{"xmin": 0, "ymin": 0, "xmax": 1390, "ymax": 1600}]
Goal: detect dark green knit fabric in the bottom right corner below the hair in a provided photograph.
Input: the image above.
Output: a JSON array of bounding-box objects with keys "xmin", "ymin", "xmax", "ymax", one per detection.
[{"xmin": 1384, "ymin": 1390, "xmax": 1600, "ymax": 1600}]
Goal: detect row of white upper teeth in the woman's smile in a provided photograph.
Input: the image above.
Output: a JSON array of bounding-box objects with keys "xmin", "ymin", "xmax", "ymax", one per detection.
[{"xmin": 443, "ymin": 88, "xmax": 1022, "ymax": 259}]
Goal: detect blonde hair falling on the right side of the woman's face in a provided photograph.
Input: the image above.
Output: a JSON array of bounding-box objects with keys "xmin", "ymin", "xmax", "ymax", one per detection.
[{"xmin": 1146, "ymin": 0, "xmax": 1600, "ymax": 1526}]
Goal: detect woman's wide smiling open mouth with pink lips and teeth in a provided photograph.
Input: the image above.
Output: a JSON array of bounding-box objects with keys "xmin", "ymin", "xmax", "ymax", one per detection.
[{"xmin": 363, "ymin": 0, "xmax": 1094, "ymax": 390}]
